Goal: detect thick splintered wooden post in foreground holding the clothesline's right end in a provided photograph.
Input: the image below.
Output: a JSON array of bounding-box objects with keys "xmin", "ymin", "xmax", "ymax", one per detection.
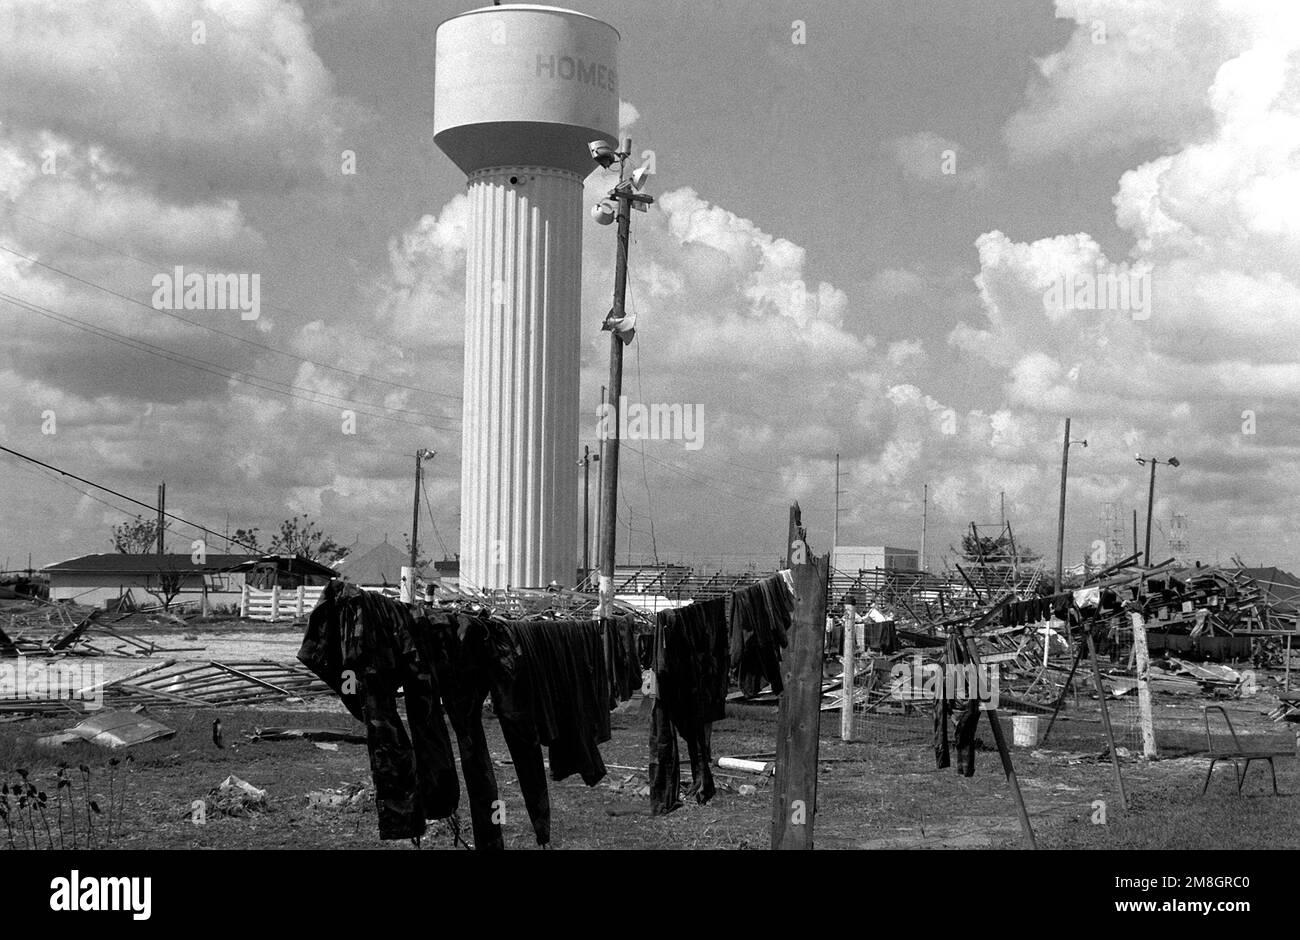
[{"xmin": 772, "ymin": 503, "xmax": 831, "ymax": 849}]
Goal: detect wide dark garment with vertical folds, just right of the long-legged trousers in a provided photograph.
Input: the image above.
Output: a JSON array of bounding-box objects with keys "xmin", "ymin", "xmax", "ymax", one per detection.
[{"xmin": 503, "ymin": 620, "xmax": 611, "ymax": 787}]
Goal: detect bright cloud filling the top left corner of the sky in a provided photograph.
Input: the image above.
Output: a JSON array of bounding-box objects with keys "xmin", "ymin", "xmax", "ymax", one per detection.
[{"xmin": 0, "ymin": 0, "xmax": 341, "ymax": 191}]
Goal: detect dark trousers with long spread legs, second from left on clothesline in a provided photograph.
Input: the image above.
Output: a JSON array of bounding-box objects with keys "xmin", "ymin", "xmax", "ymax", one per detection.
[{"xmin": 416, "ymin": 611, "xmax": 551, "ymax": 849}]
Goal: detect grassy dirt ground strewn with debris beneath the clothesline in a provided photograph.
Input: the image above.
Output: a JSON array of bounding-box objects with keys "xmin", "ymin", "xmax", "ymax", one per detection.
[{"xmin": 0, "ymin": 639, "xmax": 1300, "ymax": 850}]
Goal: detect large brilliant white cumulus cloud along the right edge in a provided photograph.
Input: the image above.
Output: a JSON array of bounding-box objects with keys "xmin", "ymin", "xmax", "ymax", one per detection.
[{"xmin": 949, "ymin": 1, "xmax": 1300, "ymax": 559}]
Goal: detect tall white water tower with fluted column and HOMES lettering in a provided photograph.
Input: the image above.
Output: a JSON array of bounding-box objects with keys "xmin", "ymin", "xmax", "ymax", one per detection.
[{"xmin": 434, "ymin": 4, "xmax": 619, "ymax": 588}]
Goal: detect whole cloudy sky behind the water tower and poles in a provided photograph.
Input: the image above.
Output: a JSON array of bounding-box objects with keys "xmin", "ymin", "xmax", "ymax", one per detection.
[{"xmin": 0, "ymin": 0, "xmax": 1300, "ymax": 568}]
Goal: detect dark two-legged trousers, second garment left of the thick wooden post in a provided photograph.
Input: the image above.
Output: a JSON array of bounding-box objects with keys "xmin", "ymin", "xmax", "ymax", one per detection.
[{"xmin": 650, "ymin": 597, "xmax": 731, "ymax": 815}]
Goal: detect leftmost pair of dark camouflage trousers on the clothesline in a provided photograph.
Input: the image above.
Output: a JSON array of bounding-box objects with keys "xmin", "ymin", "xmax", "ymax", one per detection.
[{"xmin": 298, "ymin": 581, "xmax": 460, "ymax": 839}]
